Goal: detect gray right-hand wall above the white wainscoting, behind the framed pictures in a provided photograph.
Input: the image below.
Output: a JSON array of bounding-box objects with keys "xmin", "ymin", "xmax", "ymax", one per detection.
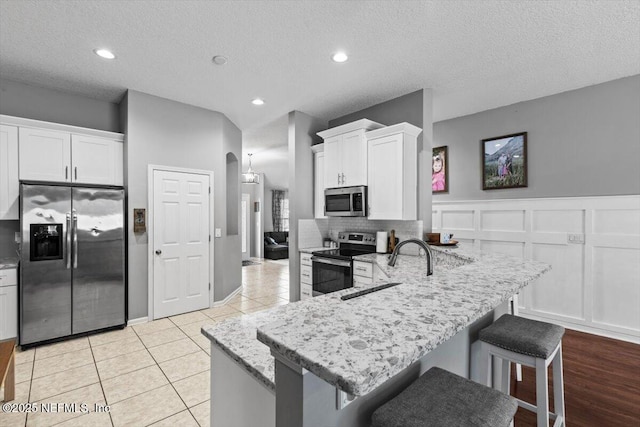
[{"xmin": 433, "ymin": 75, "xmax": 640, "ymax": 201}]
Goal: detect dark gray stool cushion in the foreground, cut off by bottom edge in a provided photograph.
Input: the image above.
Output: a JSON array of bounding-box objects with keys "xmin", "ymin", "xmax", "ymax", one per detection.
[{"xmin": 372, "ymin": 368, "xmax": 518, "ymax": 427}]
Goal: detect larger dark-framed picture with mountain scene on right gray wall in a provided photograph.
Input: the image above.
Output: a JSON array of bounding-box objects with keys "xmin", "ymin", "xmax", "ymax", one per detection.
[{"xmin": 481, "ymin": 132, "xmax": 527, "ymax": 190}]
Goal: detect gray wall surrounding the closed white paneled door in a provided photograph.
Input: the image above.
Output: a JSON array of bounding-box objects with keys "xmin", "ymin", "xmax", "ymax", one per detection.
[{"xmin": 123, "ymin": 90, "xmax": 241, "ymax": 319}]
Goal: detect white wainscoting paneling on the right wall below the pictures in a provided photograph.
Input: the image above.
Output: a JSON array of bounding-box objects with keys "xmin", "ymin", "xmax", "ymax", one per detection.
[{"xmin": 432, "ymin": 195, "xmax": 640, "ymax": 343}]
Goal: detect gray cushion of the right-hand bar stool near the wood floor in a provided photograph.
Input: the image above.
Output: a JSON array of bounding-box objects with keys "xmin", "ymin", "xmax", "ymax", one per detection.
[{"xmin": 480, "ymin": 314, "xmax": 564, "ymax": 359}]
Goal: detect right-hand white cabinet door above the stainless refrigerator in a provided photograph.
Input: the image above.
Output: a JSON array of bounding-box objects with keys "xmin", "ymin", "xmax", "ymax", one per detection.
[{"xmin": 71, "ymin": 134, "xmax": 123, "ymax": 185}]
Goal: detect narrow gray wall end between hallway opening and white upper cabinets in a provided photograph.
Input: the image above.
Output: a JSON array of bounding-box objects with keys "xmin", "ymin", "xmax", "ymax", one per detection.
[{"xmin": 289, "ymin": 111, "xmax": 327, "ymax": 301}]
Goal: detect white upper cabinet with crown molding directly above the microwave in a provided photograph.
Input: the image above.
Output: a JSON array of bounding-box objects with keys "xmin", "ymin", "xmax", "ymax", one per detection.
[{"xmin": 318, "ymin": 119, "xmax": 384, "ymax": 188}]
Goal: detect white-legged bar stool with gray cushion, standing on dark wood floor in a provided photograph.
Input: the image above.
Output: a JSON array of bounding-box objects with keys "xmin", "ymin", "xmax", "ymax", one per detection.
[{"xmin": 479, "ymin": 314, "xmax": 566, "ymax": 427}]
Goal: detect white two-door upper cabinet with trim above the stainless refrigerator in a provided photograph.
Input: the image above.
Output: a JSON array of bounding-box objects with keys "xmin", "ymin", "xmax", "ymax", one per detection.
[{"xmin": 5, "ymin": 116, "xmax": 124, "ymax": 186}]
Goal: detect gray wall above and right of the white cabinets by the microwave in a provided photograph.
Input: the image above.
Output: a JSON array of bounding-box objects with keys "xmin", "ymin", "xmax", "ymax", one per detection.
[{"xmin": 329, "ymin": 89, "xmax": 433, "ymax": 231}]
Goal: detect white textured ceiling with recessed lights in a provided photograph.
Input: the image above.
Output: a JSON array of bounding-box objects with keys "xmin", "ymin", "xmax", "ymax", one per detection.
[{"xmin": 0, "ymin": 0, "xmax": 640, "ymax": 141}]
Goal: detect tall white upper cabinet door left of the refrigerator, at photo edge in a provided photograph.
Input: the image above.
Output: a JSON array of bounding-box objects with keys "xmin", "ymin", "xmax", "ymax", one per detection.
[{"xmin": 0, "ymin": 125, "xmax": 20, "ymax": 219}]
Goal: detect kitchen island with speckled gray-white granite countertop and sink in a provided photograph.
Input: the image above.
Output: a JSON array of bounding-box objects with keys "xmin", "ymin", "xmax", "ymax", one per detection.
[{"xmin": 203, "ymin": 244, "xmax": 550, "ymax": 427}]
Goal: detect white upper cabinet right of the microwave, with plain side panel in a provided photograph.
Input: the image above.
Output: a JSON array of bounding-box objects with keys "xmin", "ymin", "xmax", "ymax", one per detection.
[{"xmin": 366, "ymin": 123, "xmax": 422, "ymax": 220}]
